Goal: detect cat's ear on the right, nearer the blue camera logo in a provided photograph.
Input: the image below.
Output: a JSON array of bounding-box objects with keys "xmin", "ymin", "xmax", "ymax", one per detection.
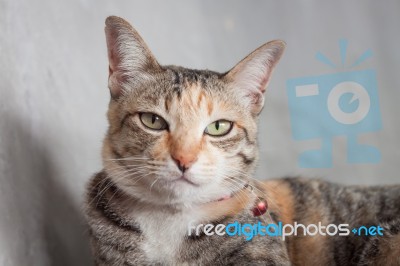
[{"xmin": 224, "ymin": 40, "xmax": 286, "ymax": 114}]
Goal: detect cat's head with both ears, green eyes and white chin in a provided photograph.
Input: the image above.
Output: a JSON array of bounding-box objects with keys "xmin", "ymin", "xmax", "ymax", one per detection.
[{"xmin": 103, "ymin": 17, "xmax": 285, "ymax": 208}]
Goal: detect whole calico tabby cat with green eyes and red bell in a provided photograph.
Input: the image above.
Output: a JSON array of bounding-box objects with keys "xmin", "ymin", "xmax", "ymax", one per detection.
[{"xmin": 85, "ymin": 16, "xmax": 400, "ymax": 265}]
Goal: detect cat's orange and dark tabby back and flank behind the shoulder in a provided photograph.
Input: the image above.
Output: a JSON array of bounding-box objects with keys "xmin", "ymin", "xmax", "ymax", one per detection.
[{"xmin": 261, "ymin": 178, "xmax": 400, "ymax": 265}]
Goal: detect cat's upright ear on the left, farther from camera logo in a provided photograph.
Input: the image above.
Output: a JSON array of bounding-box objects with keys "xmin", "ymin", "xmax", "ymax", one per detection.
[{"xmin": 105, "ymin": 16, "xmax": 161, "ymax": 98}]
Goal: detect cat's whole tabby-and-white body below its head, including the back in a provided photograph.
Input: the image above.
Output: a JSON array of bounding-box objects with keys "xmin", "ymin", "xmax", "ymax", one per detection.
[{"xmin": 88, "ymin": 172, "xmax": 400, "ymax": 265}]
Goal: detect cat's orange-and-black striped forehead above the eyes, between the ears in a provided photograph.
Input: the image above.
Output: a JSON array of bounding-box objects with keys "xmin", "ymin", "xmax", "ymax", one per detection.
[{"xmin": 123, "ymin": 66, "xmax": 242, "ymax": 125}]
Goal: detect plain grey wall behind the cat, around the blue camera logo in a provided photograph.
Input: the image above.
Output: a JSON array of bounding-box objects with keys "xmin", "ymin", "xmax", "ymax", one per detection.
[{"xmin": 0, "ymin": 0, "xmax": 400, "ymax": 265}]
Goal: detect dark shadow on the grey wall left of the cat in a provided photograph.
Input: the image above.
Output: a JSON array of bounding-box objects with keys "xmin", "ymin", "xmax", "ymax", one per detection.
[{"xmin": 0, "ymin": 114, "xmax": 93, "ymax": 265}]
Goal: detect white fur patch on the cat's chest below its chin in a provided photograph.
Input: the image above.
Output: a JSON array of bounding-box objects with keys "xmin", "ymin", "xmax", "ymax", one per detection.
[{"xmin": 134, "ymin": 206, "xmax": 200, "ymax": 265}]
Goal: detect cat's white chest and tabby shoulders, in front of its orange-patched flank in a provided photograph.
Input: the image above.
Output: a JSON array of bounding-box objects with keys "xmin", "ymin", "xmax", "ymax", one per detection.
[{"xmin": 89, "ymin": 173, "xmax": 290, "ymax": 265}]
